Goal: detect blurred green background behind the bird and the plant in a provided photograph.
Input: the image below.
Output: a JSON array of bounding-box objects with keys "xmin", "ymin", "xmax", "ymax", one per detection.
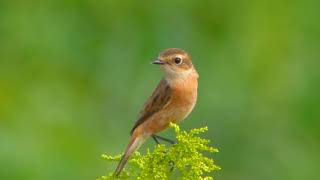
[{"xmin": 0, "ymin": 0, "xmax": 320, "ymax": 180}]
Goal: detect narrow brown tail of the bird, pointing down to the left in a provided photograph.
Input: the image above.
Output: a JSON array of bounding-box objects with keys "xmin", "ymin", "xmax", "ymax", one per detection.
[{"xmin": 114, "ymin": 134, "xmax": 145, "ymax": 176}]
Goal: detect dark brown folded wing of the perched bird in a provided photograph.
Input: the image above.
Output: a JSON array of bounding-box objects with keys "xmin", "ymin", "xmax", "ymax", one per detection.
[{"xmin": 131, "ymin": 79, "xmax": 171, "ymax": 134}]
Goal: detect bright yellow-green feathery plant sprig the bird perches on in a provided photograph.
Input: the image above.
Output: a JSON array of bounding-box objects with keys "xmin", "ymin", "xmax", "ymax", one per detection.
[{"xmin": 99, "ymin": 124, "xmax": 220, "ymax": 180}]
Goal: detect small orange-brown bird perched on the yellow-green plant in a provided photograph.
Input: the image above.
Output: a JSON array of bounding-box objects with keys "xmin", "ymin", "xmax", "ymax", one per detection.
[{"xmin": 115, "ymin": 48, "xmax": 199, "ymax": 176}]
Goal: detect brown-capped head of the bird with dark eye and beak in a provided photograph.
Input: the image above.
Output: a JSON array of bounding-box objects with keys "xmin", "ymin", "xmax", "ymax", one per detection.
[{"xmin": 153, "ymin": 48, "xmax": 193, "ymax": 78}]
